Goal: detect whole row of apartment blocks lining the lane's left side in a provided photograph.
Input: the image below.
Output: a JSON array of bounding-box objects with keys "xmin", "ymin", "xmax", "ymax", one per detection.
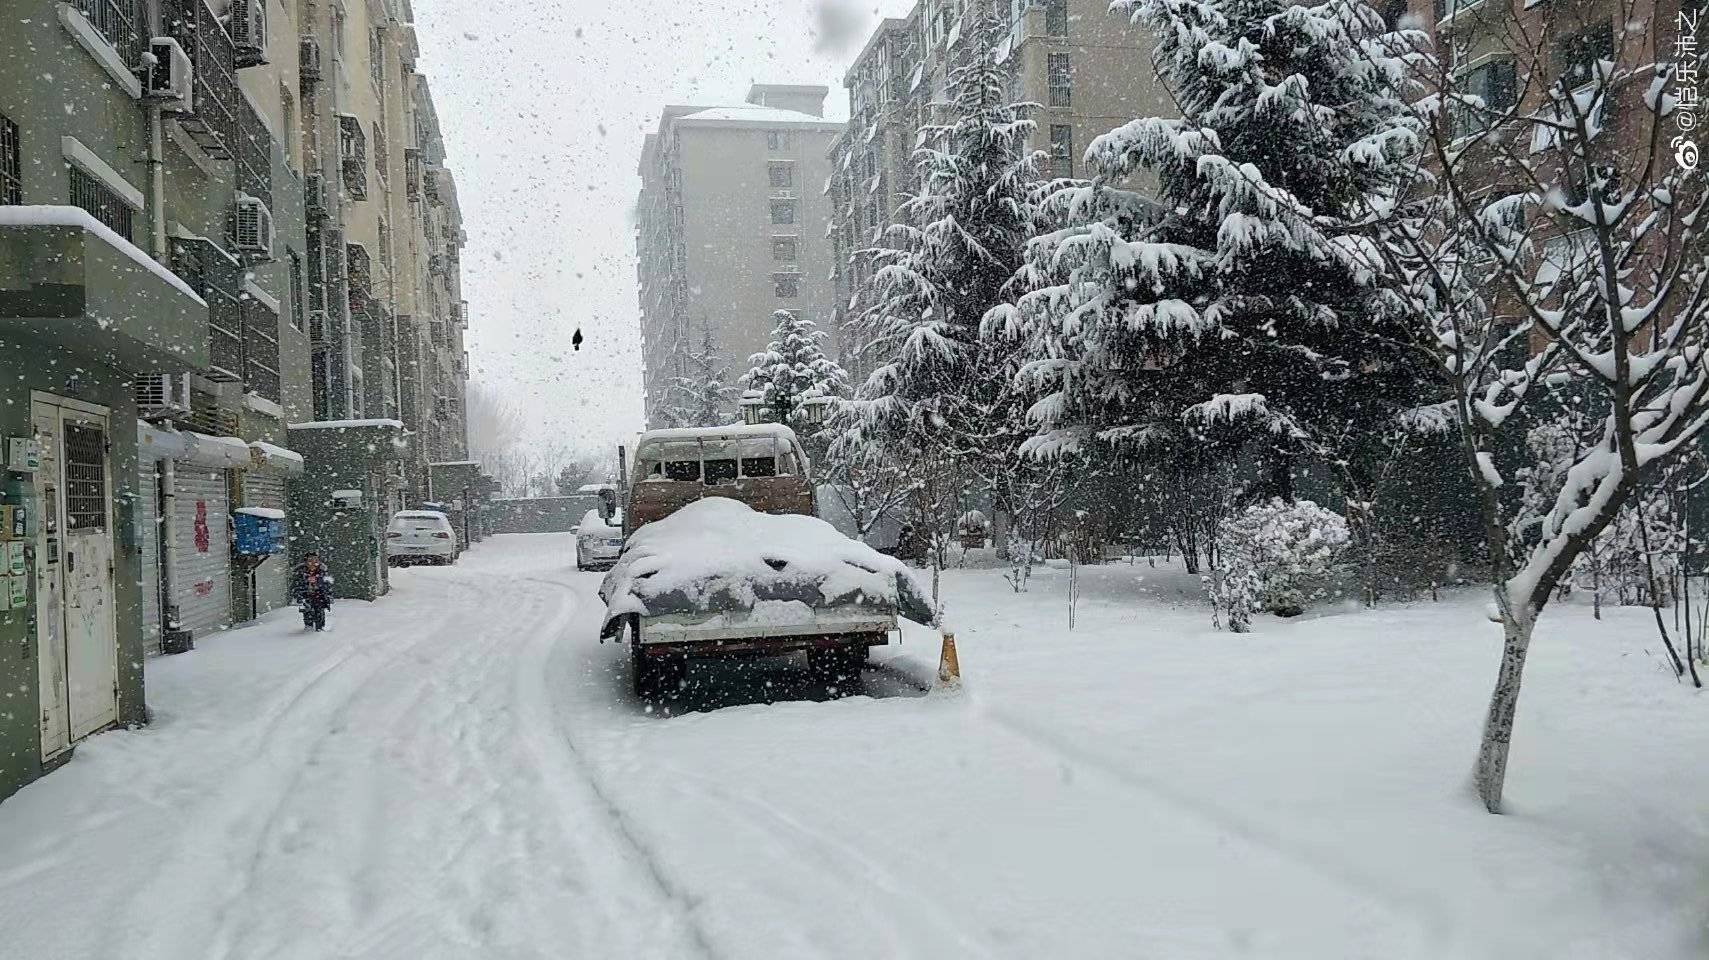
[{"xmin": 0, "ymin": 0, "xmax": 467, "ymax": 798}]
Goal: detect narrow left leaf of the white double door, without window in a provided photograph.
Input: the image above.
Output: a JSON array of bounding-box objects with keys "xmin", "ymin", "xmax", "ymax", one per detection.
[{"xmin": 31, "ymin": 400, "xmax": 72, "ymax": 760}]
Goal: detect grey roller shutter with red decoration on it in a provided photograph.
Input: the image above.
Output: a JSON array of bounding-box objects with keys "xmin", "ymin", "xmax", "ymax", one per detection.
[{"xmin": 173, "ymin": 463, "xmax": 231, "ymax": 639}]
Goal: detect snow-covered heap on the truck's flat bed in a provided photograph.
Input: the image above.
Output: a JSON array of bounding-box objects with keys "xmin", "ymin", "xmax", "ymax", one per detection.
[{"xmin": 600, "ymin": 497, "xmax": 931, "ymax": 623}]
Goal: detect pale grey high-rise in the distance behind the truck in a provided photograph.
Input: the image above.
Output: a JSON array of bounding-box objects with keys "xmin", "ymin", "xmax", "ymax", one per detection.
[{"xmin": 636, "ymin": 84, "xmax": 843, "ymax": 427}]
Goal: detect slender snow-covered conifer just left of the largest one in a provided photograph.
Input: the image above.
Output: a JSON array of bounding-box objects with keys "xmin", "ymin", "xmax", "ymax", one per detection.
[{"xmin": 849, "ymin": 7, "xmax": 1039, "ymax": 475}]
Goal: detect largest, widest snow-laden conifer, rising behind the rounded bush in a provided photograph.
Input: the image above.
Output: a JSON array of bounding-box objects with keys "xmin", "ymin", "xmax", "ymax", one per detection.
[{"xmin": 991, "ymin": 0, "xmax": 1424, "ymax": 500}]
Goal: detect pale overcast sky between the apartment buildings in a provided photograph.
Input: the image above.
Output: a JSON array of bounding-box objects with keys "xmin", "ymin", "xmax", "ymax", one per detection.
[{"xmin": 415, "ymin": 0, "xmax": 911, "ymax": 449}]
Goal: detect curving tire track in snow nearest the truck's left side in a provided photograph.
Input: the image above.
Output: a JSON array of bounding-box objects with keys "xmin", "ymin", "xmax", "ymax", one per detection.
[{"xmin": 516, "ymin": 577, "xmax": 719, "ymax": 958}]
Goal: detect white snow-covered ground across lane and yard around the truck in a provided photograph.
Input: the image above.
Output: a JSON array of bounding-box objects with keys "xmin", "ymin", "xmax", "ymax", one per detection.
[{"xmin": 0, "ymin": 535, "xmax": 1709, "ymax": 960}]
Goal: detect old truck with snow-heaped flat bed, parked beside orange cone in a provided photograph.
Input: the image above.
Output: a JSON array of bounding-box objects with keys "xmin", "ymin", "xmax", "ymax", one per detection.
[{"xmin": 600, "ymin": 424, "xmax": 931, "ymax": 695}]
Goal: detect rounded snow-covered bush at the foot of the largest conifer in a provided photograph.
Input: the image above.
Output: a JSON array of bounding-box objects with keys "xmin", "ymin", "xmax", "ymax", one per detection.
[{"xmin": 1208, "ymin": 499, "xmax": 1350, "ymax": 634}]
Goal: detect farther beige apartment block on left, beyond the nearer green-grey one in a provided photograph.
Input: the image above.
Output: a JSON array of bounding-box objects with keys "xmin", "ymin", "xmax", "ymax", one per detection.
[{"xmin": 292, "ymin": 0, "xmax": 468, "ymax": 596}]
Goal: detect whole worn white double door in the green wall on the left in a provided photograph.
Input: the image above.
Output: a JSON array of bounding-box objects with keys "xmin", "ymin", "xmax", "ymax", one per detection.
[{"xmin": 31, "ymin": 398, "xmax": 118, "ymax": 758}]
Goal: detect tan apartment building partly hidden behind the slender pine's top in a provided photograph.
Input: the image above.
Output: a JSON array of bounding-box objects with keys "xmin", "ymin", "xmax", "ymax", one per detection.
[{"xmin": 827, "ymin": 0, "xmax": 1172, "ymax": 362}]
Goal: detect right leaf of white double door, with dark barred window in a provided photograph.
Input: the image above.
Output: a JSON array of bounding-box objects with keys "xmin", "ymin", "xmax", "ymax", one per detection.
[{"xmin": 60, "ymin": 410, "xmax": 118, "ymax": 740}]
